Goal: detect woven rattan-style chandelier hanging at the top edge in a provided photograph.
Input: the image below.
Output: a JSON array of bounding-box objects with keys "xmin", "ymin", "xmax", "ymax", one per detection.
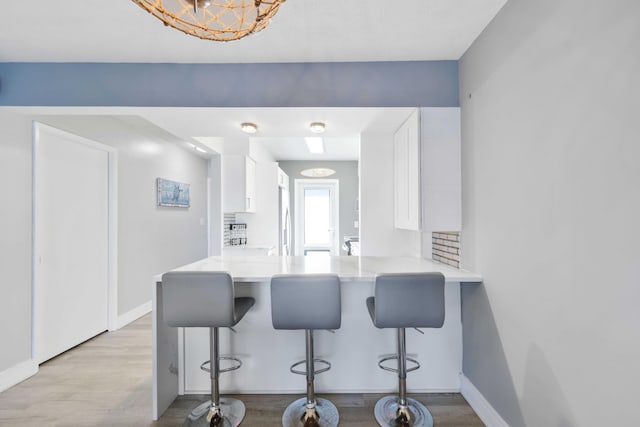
[{"xmin": 132, "ymin": 0, "xmax": 285, "ymax": 41}]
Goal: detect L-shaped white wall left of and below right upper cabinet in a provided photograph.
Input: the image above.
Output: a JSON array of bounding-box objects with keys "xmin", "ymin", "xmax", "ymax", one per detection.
[{"xmin": 360, "ymin": 129, "xmax": 421, "ymax": 256}]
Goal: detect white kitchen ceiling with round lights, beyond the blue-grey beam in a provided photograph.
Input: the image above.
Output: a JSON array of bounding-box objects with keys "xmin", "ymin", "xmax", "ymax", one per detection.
[{"xmin": 146, "ymin": 108, "xmax": 413, "ymax": 160}]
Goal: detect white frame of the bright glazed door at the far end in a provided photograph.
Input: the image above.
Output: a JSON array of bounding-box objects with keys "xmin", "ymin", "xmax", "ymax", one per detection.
[{"xmin": 294, "ymin": 179, "xmax": 340, "ymax": 255}]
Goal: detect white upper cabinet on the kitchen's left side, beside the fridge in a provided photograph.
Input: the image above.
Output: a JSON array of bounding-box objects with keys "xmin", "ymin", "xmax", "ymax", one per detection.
[{"xmin": 222, "ymin": 155, "xmax": 256, "ymax": 213}]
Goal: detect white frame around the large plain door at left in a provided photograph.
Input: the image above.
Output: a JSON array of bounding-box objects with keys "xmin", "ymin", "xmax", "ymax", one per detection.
[{"xmin": 31, "ymin": 121, "xmax": 118, "ymax": 363}]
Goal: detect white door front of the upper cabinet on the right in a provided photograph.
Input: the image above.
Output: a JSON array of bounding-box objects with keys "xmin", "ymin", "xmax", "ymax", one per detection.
[{"xmin": 393, "ymin": 110, "xmax": 422, "ymax": 230}]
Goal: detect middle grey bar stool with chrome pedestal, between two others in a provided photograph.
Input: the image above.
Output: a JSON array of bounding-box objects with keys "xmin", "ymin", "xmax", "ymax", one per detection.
[{"xmin": 271, "ymin": 274, "xmax": 342, "ymax": 427}]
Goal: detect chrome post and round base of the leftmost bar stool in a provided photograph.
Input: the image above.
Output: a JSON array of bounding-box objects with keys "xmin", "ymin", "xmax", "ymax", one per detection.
[{"xmin": 184, "ymin": 328, "xmax": 246, "ymax": 427}]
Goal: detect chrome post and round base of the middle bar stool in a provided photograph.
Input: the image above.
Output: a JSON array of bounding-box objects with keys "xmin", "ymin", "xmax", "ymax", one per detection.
[{"xmin": 282, "ymin": 329, "xmax": 339, "ymax": 427}]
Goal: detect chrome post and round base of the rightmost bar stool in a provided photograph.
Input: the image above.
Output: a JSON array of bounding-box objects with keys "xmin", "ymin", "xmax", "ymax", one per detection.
[{"xmin": 374, "ymin": 328, "xmax": 433, "ymax": 427}]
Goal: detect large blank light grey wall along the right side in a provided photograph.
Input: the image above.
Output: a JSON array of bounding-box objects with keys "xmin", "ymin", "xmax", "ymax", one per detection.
[{"xmin": 460, "ymin": 0, "xmax": 640, "ymax": 427}]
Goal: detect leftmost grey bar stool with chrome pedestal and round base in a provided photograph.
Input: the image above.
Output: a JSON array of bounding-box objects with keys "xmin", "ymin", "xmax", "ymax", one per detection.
[{"xmin": 162, "ymin": 271, "xmax": 255, "ymax": 427}]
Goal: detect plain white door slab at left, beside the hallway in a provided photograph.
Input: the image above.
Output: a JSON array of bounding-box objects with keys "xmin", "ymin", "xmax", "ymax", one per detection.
[{"xmin": 34, "ymin": 125, "xmax": 109, "ymax": 363}]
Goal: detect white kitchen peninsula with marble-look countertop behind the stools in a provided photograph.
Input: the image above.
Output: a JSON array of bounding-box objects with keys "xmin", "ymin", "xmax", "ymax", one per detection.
[{"xmin": 153, "ymin": 256, "xmax": 482, "ymax": 420}]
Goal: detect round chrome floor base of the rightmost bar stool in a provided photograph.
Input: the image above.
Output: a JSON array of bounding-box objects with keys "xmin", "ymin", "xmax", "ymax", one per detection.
[{"xmin": 373, "ymin": 396, "xmax": 433, "ymax": 427}]
